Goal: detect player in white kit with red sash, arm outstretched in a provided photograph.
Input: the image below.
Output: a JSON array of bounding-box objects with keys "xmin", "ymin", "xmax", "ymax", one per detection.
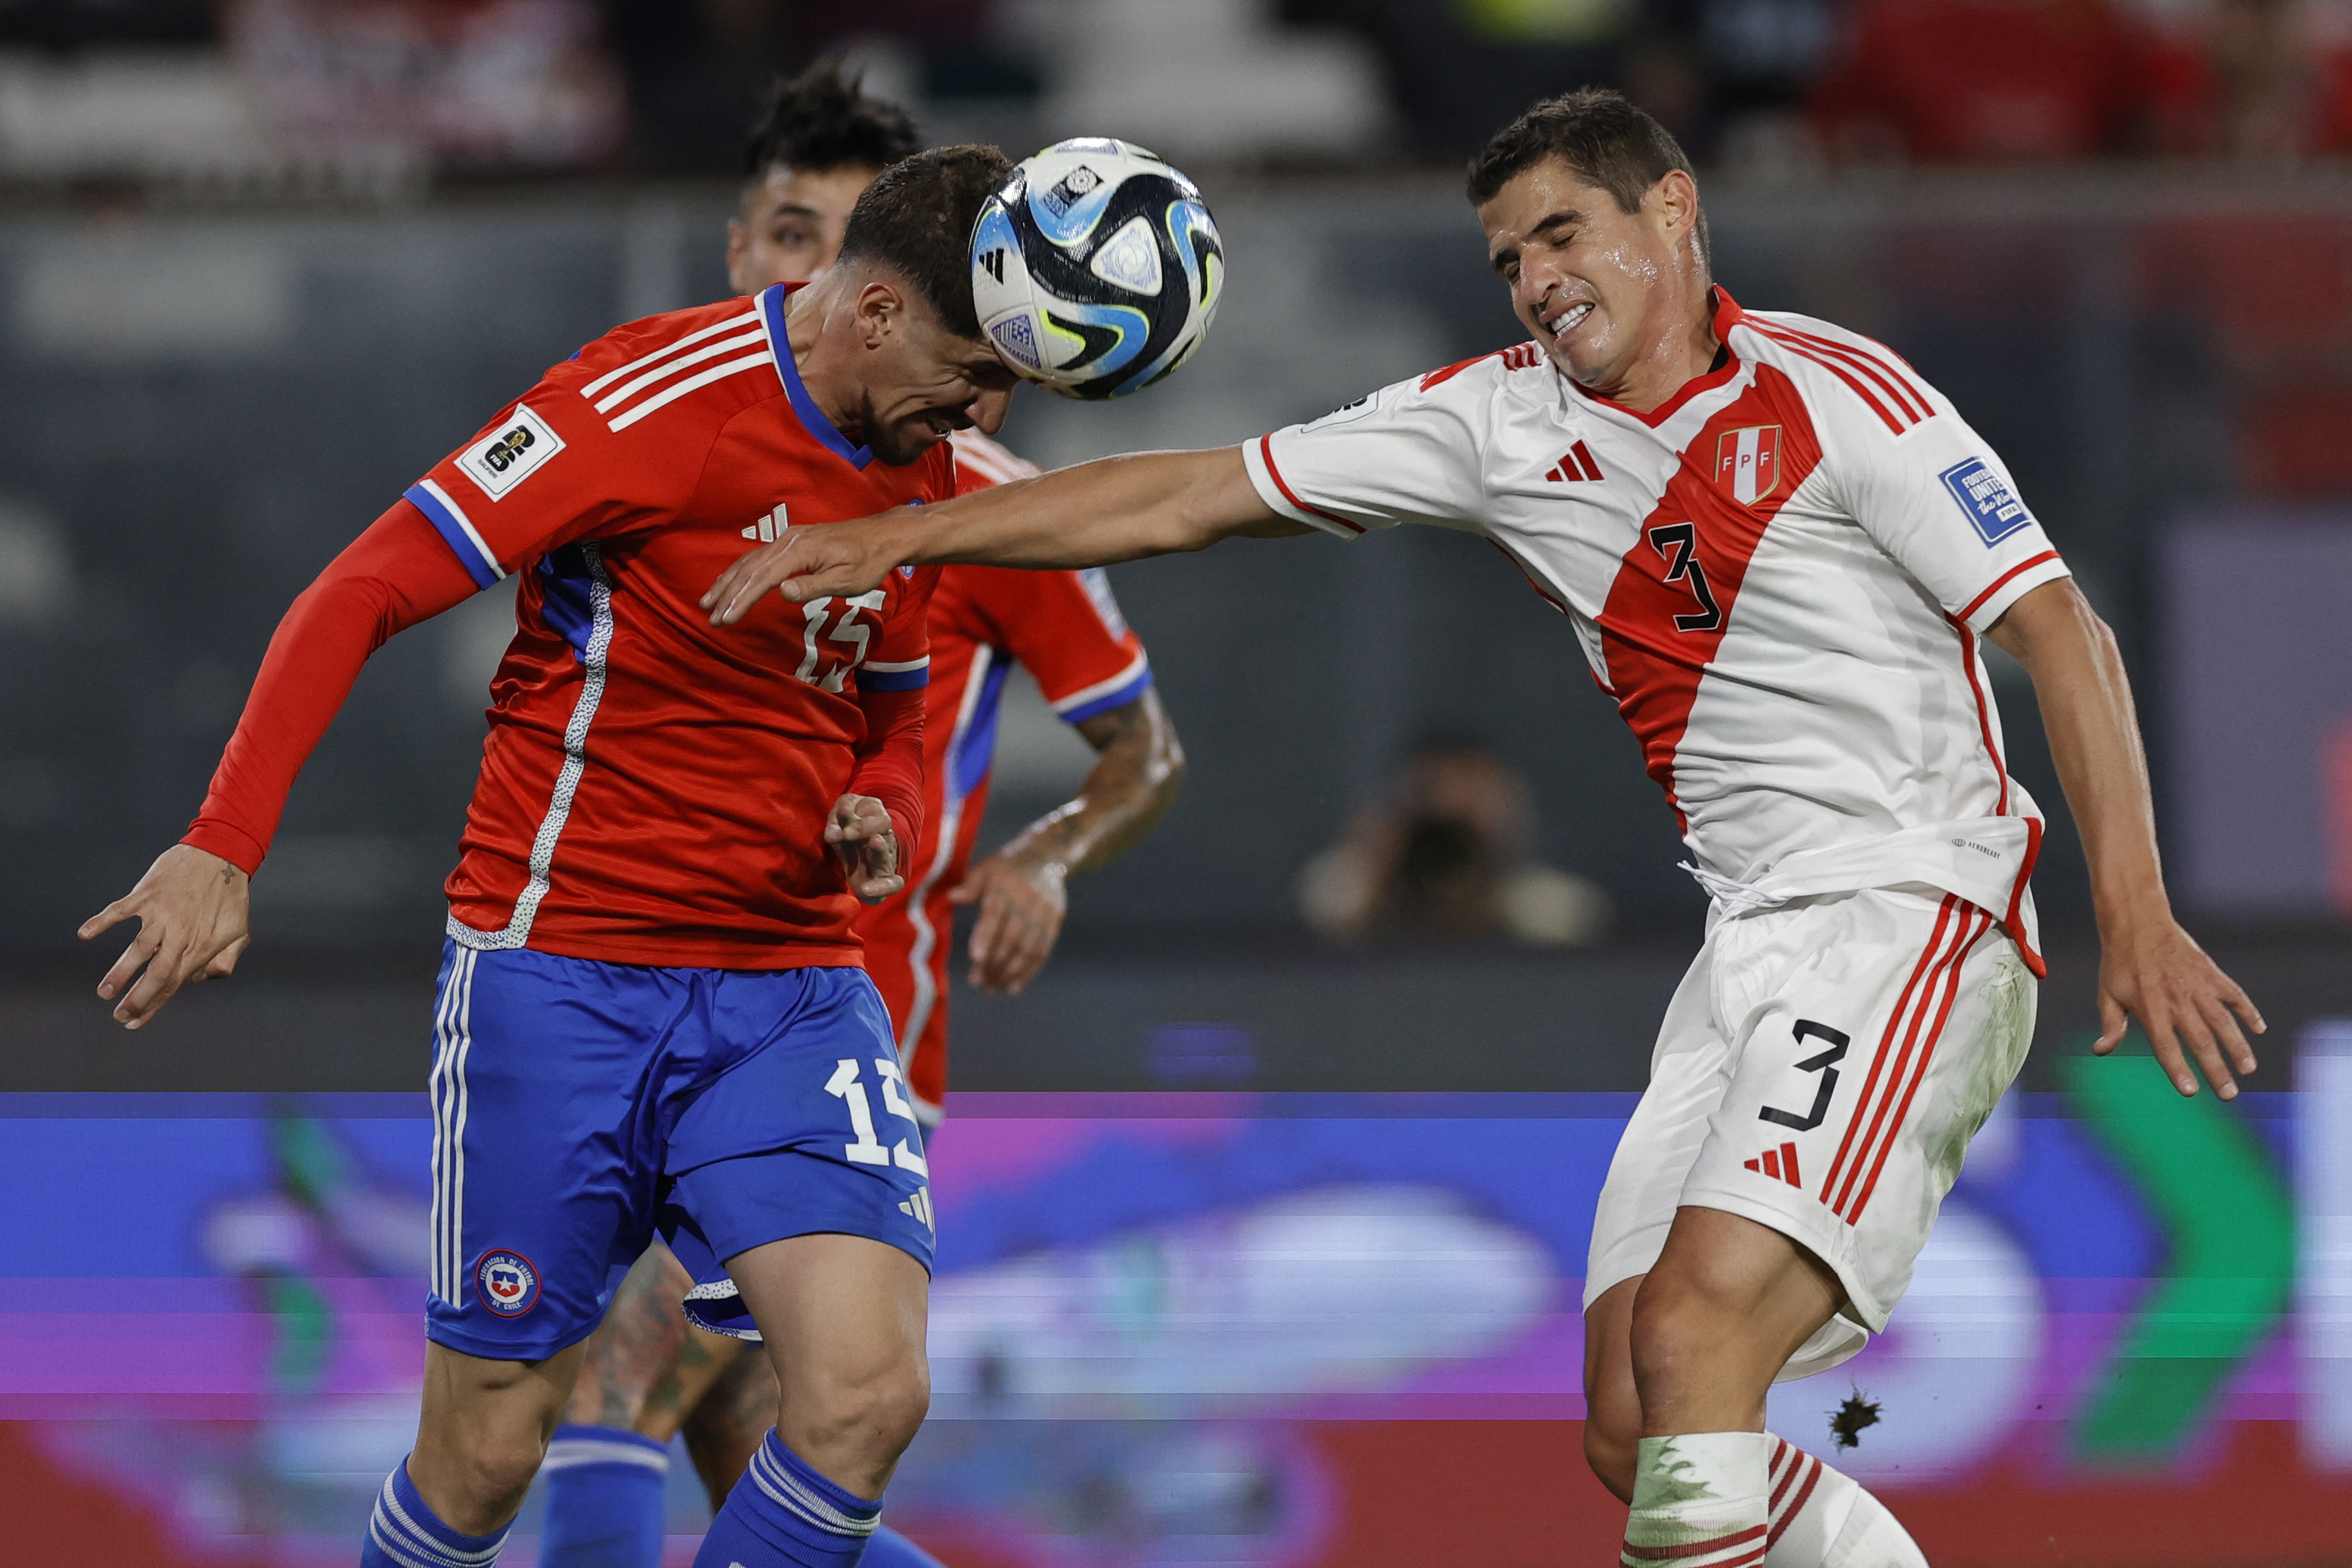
[{"xmin": 704, "ymin": 92, "xmax": 2263, "ymax": 1568}]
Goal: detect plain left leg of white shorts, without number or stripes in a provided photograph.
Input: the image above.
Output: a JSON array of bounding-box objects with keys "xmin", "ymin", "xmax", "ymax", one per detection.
[{"xmin": 1585, "ymin": 941, "xmax": 1731, "ymax": 1310}]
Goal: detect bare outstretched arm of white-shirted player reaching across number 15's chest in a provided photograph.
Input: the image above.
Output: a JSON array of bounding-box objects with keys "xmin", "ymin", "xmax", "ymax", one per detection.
[{"xmin": 704, "ymin": 447, "xmax": 1313, "ymax": 625}]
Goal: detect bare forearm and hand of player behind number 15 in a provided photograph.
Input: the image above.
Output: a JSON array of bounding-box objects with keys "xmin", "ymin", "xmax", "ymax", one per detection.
[{"xmin": 948, "ymin": 687, "xmax": 1183, "ymax": 994}]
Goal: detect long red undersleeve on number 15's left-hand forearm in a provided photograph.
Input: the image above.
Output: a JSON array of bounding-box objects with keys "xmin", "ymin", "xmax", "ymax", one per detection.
[{"xmin": 181, "ymin": 501, "xmax": 486, "ymax": 875}]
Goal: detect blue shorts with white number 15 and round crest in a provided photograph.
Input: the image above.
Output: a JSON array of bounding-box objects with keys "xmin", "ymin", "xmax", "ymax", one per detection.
[{"xmin": 426, "ymin": 943, "xmax": 932, "ymax": 1361}]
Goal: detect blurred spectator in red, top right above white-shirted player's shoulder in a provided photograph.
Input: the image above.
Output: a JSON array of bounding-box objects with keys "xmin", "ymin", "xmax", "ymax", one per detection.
[{"xmin": 1811, "ymin": 0, "xmax": 2152, "ymax": 162}]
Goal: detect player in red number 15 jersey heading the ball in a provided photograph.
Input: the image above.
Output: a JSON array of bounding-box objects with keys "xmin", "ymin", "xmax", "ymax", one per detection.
[{"xmin": 83, "ymin": 148, "xmax": 1014, "ymax": 1568}]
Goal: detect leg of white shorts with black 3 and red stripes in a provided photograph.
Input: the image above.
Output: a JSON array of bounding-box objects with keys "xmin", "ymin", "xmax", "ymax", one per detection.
[{"xmin": 1682, "ymin": 889, "xmax": 2032, "ymax": 1371}]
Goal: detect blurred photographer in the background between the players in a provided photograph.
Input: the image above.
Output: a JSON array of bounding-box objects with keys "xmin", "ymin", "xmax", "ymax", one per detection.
[{"xmin": 1299, "ymin": 736, "xmax": 1609, "ymax": 947}]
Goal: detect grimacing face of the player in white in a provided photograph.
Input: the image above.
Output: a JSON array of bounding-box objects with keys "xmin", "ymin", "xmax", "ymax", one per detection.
[{"xmin": 1479, "ymin": 157, "xmax": 1677, "ymax": 395}]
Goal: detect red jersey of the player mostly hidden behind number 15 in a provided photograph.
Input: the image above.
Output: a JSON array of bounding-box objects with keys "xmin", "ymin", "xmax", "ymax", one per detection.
[{"xmin": 859, "ymin": 430, "xmax": 1152, "ymax": 1121}]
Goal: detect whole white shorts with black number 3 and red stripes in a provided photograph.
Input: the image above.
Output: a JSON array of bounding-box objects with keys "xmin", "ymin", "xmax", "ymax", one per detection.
[{"xmin": 1585, "ymin": 887, "xmax": 2037, "ymax": 1380}]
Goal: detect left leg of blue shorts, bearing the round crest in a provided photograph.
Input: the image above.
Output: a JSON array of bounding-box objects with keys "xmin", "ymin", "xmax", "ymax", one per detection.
[{"xmin": 426, "ymin": 947, "xmax": 659, "ymax": 1361}]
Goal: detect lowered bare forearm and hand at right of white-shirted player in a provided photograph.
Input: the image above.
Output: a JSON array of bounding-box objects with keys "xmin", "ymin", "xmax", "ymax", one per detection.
[{"xmin": 1985, "ymin": 578, "xmax": 2267, "ymax": 1100}]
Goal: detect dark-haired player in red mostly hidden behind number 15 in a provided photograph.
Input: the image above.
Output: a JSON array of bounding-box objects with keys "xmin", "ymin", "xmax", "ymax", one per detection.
[{"xmin": 539, "ymin": 61, "xmax": 1183, "ymax": 1568}]
